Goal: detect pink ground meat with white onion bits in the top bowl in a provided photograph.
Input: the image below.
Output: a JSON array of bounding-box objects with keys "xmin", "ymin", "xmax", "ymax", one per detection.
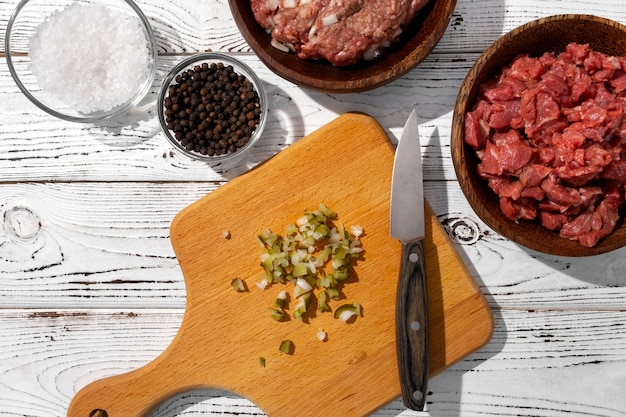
[{"xmin": 250, "ymin": 0, "xmax": 428, "ymax": 66}]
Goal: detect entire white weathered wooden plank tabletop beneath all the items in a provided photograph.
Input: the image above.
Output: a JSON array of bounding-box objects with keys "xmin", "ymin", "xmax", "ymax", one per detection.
[{"xmin": 0, "ymin": 0, "xmax": 626, "ymax": 417}]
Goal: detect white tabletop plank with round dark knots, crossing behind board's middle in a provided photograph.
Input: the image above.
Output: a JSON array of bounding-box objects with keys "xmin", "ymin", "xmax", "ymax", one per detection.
[{"xmin": 0, "ymin": 179, "xmax": 626, "ymax": 310}]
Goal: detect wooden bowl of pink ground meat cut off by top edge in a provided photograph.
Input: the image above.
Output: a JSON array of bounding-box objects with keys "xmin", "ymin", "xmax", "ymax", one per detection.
[{"xmin": 229, "ymin": 0, "xmax": 456, "ymax": 93}]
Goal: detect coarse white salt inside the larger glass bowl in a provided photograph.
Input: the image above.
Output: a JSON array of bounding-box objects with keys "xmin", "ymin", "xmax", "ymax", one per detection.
[{"xmin": 29, "ymin": 3, "xmax": 152, "ymax": 114}]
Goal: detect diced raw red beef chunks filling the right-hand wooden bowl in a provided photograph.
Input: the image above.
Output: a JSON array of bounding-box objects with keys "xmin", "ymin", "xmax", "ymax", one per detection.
[{"xmin": 464, "ymin": 43, "xmax": 626, "ymax": 247}]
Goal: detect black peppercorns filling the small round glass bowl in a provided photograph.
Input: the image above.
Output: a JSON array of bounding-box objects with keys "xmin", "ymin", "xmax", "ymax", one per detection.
[{"xmin": 163, "ymin": 59, "xmax": 261, "ymax": 156}]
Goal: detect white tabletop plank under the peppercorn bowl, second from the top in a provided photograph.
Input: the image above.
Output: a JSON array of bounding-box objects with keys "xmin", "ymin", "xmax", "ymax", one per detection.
[{"xmin": 0, "ymin": 55, "xmax": 468, "ymax": 182}]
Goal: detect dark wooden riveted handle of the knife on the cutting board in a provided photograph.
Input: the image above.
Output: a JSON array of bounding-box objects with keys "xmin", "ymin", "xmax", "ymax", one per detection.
[{"xmin": 396, "ymin": 239, "xmax": 429, "ymax": 411}]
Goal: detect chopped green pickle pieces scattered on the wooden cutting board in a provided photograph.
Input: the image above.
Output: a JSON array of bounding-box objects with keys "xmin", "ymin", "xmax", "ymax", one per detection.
[{"xmin": 246, "ymin": 204, "xmax": 364, "ymax": 358}]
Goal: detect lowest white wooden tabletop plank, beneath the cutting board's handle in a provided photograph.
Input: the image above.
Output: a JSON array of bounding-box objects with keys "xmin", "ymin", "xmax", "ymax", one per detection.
[{"xmin": 0, "ymin": 308, "xmax": 626, "ymax": 417}]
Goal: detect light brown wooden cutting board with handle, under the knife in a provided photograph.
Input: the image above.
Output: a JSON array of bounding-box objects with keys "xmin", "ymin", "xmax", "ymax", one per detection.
[{"xmin": 68, "ymin": 113, "xmax": 493, "ymax": 417}]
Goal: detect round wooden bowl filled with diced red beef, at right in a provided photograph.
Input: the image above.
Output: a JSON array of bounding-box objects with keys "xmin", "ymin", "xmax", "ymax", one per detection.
[{"xmin": 451, "ymin": 15, "xmax": 626, "ymax": 257}]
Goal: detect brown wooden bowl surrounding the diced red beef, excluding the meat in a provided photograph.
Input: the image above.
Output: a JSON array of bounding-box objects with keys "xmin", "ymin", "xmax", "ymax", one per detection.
[{"xmin": 450, "ymin": 14, "xmax": 626, "ymax": 257}]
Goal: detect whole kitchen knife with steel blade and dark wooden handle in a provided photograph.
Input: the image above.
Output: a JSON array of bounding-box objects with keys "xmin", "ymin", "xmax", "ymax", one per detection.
[{"xmin": 390, "ymin": 110, "xmax": 429, "ymax": 411}]
